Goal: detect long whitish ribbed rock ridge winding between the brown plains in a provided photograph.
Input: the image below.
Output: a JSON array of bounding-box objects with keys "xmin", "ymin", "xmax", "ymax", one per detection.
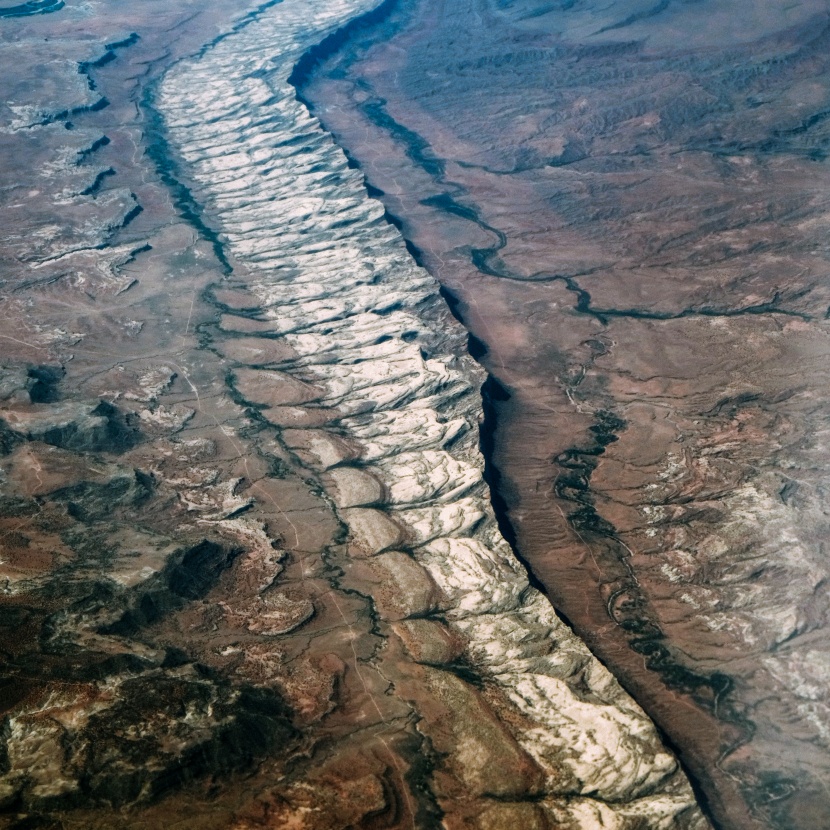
[{"xmin": 157, "ymin": 0, "xmax": 704, "ymax": 828}]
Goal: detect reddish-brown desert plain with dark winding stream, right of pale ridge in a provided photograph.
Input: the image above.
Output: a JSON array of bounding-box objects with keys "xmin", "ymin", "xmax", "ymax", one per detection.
[{"xmin": 302, "ymin": 0, "xmax": 830, "ymax": 830}]
